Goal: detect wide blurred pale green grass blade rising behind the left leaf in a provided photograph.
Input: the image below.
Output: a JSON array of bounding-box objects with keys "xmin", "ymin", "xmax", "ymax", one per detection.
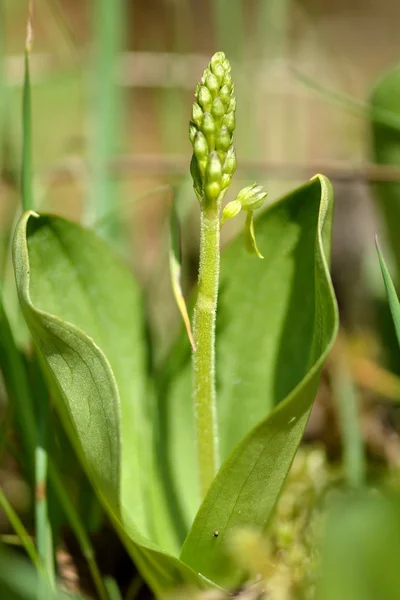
[{"xmin": 86, "ymin": 0, "xmax": 125, "ymax": 242}]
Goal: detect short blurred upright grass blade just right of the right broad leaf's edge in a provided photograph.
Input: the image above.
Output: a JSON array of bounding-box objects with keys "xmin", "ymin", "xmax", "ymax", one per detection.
[{"xmin": 332, "ymin": 337, "xmax": 365, "ymax": 488}]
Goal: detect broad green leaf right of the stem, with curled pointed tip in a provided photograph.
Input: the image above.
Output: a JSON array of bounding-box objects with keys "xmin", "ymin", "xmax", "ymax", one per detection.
[{"xmin": 160, "ymin": 176, "xmax": 337, "ymax": 584}]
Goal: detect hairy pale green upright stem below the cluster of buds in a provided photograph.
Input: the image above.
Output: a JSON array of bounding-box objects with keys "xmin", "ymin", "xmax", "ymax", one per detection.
[{"xmin": 193, "ymin": 209, "xmax": 220, "ymax": 497}]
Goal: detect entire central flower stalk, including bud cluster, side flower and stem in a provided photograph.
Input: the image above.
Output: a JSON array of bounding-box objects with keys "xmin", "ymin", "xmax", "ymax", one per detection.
[{"xmin": 191, "ymin": 52, "xmax": 266, "ymax": 497}]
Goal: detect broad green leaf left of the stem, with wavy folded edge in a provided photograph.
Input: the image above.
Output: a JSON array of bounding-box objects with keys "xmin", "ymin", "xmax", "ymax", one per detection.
[{"xmin": 13, "ymin": 212, "xmax": 212, "ymax": 594}]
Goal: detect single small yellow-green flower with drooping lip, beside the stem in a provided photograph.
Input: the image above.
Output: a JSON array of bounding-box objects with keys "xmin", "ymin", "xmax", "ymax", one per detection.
[{"xmin": 221, "ymin": 183, "xmax": 267, "ymax": 258}]
